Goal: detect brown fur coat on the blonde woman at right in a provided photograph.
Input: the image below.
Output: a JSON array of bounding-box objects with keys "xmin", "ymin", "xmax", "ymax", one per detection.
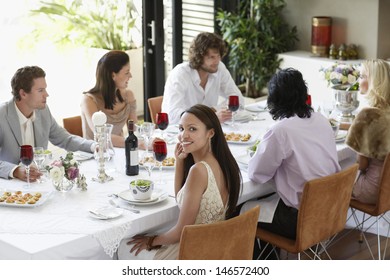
[{"xmin": 346, "ymin": 107, "xmax": 390, "ymax": 160}]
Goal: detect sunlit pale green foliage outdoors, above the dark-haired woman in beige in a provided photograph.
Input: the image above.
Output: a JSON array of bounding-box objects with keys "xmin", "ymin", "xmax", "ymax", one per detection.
[{"xmin": 31, "ymin": 0, "xmax": 141, "ymax": 50}]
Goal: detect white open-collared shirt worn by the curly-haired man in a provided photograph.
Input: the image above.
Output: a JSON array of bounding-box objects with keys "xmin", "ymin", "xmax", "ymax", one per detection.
[{"xmin": 162, "ymin": 62, "xmax": 244, "ymax": 124}]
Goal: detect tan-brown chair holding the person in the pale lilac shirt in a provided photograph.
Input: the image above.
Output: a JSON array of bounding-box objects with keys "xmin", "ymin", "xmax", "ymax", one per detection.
[{"xmin": 256, "ymin": 164, "xmax": 358, "ymax": 259}]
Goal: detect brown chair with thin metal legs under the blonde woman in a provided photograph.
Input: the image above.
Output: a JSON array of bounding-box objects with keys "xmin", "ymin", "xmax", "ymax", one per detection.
[{"xmin": 350, "ymin": 154, "xmax": 390, "ymax": 260}]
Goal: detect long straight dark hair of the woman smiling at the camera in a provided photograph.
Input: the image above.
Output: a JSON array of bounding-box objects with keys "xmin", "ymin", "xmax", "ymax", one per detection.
[{"xmin": 182, "ymin": 104, "xmax": 241, "ymax": 218}]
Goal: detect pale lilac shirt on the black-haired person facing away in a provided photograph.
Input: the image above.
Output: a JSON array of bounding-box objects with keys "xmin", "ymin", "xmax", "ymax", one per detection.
[{"xmin": 248, "ymin": 112, "xmax": 341, "ymax": 222}]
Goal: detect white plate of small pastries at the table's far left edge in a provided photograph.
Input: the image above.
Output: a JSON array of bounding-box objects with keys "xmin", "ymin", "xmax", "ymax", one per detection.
[{"xmin": 0, "ymin": 190, "xmax": 51, "ymax": 208}]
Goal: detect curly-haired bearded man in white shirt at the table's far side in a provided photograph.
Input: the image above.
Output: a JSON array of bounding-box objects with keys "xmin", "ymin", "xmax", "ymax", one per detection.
[{"xmin": 162, "ymin": 32, "xmax": 244, "ymax": 124}]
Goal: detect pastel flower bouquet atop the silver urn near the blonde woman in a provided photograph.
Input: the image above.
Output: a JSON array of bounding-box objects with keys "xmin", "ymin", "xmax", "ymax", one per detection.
[{"xmin": 320, "ymin": 63, "xmax": 360, "ymax": 88}]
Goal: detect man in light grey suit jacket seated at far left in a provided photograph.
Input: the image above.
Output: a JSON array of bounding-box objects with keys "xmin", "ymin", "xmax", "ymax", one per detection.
[{"xmin": 0, "ymin": 66, "xmax": 96, "ymax": 181}]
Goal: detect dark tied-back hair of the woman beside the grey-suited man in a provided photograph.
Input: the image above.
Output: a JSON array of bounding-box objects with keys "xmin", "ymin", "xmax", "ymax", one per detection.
[{"xmin": 84, "ymin": 51, "xmax": 130, "ymax": 110}]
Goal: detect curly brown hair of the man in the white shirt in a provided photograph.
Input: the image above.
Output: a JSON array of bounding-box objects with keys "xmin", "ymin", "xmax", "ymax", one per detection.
[{"xmin": 188, "ymin": 32, "xmax": 227, "ymax": 69}]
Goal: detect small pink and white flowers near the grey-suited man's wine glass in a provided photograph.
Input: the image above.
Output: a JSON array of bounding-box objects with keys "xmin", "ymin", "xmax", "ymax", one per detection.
[{"xmin": 47, "ymin": 152, "xmax": 79, "ymax": 182}]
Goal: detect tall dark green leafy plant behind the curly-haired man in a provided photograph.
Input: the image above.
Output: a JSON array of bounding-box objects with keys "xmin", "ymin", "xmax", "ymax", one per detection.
[{"xmin": 217, "ymin": 0, "xmax": 298, "ymax": 98}]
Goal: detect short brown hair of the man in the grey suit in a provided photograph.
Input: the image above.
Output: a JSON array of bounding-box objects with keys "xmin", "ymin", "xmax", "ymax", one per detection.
[{"xmin": 11, "ymin": 66, "xmax": 46, "ymax": 101}]
